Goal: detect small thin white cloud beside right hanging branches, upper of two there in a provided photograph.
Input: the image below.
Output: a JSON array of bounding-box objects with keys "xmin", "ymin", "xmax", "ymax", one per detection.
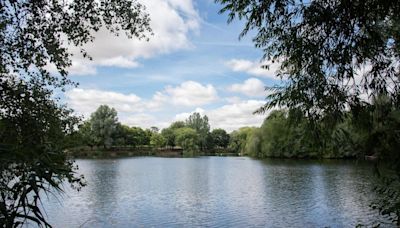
[{"xmin": 225, "ymin": 59, "xmax": 279, "ymax": 79}]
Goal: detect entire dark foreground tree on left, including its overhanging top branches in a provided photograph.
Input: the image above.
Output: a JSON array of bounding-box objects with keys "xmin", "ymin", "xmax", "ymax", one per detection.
[{"xmin": 0, "ymin": 0, "xmax": 151, "ymax": 227}]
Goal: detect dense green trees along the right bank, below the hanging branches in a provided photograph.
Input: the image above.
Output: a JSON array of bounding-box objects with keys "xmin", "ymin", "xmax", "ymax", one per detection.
[{"xmin": 230, "ymin": 95, "xmax": 400, "ymax": 160}]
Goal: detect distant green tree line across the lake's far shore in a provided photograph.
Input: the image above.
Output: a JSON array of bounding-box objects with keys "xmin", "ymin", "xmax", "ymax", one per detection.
[{"xmin": 67, "ymin": 105, "xmax": 230, "ymax": 156}]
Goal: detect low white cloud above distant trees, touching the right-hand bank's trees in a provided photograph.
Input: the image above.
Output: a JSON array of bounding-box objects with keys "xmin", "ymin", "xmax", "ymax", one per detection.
[{"xmin": 175, "ymin": 100, "xmax": 268, "ymax": 132}]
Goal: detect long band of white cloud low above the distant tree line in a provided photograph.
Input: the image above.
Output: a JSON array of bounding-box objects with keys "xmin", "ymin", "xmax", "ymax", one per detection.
[{"xmin": 66, "ymin": 81, "xmax": 265, "ymax": 131}]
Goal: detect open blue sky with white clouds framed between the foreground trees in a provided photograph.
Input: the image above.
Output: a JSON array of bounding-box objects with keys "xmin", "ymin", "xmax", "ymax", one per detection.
[{"xmin": 63, "ymin": 0, "xmax": 279, "ymax": 132}]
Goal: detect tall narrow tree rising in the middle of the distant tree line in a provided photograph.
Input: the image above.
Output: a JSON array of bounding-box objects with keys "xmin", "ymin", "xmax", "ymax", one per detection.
[{"xmin": 186, "ymin": 112, "xmax": 210, "ymax": 151}]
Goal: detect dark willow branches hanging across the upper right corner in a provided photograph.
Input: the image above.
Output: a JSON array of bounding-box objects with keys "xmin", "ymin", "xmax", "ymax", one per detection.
[{"xmin": 216, "ymin": 0, "xmax": 400, "ymax": 224}]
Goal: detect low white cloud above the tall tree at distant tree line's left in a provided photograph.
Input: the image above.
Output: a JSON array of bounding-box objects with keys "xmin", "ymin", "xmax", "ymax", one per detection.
[{"xmin": 66, "ymin": 88, "xmax": 143, "ymax": 117}]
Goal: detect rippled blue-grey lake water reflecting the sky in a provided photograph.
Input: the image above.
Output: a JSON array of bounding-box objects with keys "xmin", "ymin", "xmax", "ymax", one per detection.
[{"xmin": 40, "ymin": 157, "xmax": 390, "ymax": 227}]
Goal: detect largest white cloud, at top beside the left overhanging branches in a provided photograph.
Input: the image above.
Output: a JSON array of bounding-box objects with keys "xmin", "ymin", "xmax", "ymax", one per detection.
[{"xmin": 70, "ymin": 0, "xmax": 200, "ymax": 75}]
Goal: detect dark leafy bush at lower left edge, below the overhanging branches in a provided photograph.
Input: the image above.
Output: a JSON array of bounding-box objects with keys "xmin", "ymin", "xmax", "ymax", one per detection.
[{"xmin": 0, "ymin": 80, "xmax": 84, "ymax": 227}]
